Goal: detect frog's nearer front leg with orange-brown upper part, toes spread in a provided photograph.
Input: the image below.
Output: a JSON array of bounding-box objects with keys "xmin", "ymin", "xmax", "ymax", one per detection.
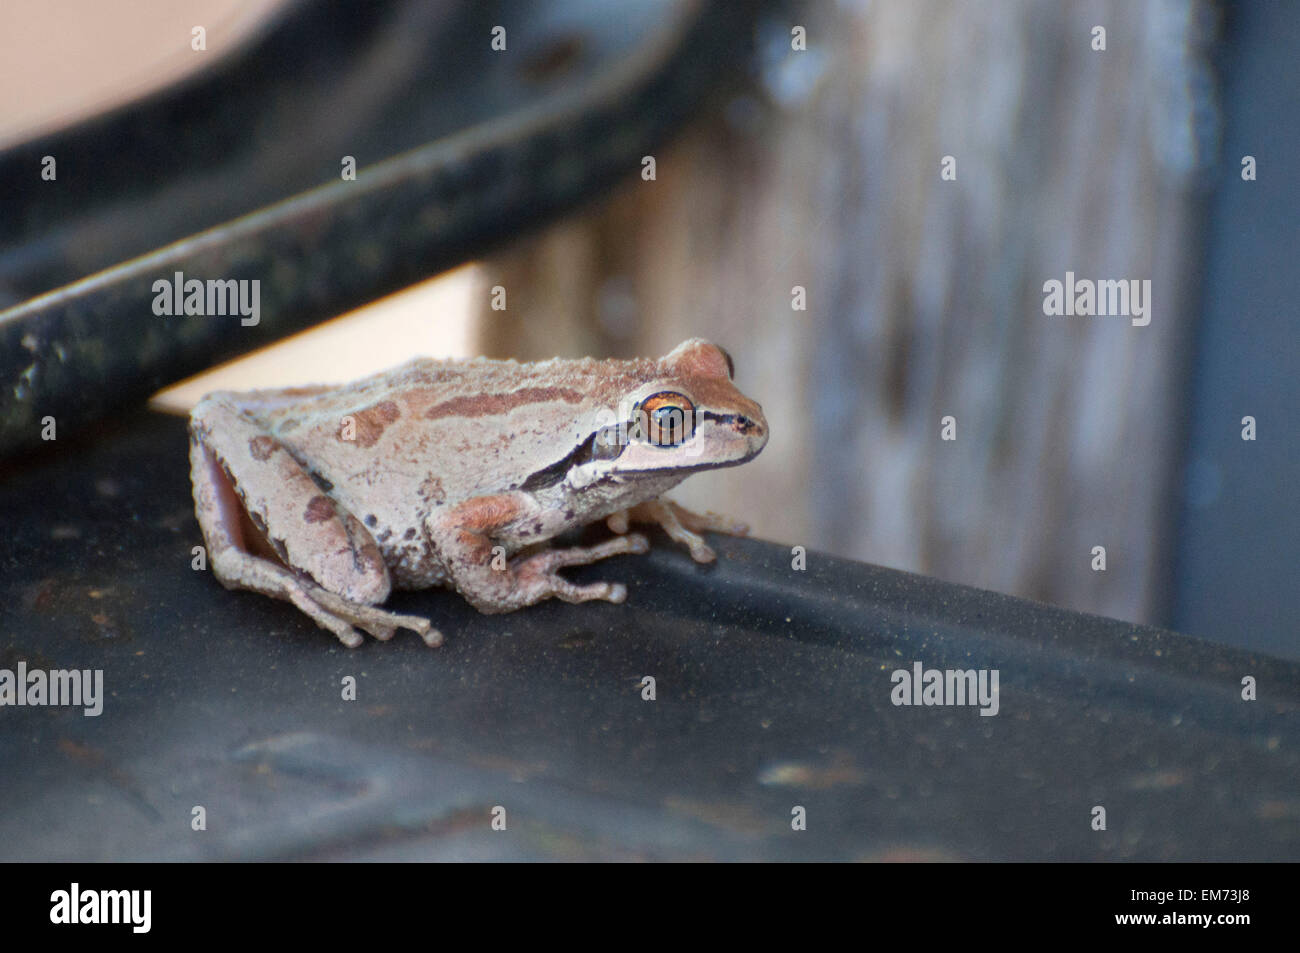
[{"xmin": 428, "ymin": 493, "xmax": 650, "ymax": 612}]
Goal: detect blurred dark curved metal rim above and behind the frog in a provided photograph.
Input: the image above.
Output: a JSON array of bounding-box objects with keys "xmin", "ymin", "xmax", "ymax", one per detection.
[{"xmin": 0, "ymin": 0, "xmax": 759, "ymax": 454}]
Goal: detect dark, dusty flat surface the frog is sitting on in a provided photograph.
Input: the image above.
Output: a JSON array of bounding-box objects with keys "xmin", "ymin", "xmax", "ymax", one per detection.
[{"xmin": 0, "ymin": 415, "xmax": 1300, "ymax": 861}]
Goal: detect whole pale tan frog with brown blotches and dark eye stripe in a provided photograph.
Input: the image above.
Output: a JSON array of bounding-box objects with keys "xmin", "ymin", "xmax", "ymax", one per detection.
[{"xmin": 190, "ymin": 338, "xmax": 767, "ymax": 647}]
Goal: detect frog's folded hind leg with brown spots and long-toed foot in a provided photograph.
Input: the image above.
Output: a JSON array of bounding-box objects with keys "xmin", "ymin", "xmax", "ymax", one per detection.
[{"xmin": 190, "ymin": 395, "xmax": 442, "ymax": 647}]
